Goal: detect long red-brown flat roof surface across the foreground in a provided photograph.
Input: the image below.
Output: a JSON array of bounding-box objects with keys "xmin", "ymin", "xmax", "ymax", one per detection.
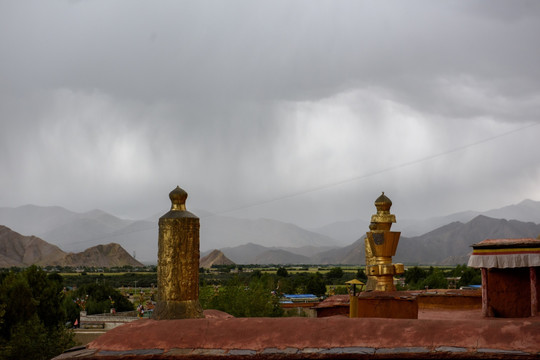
[{"xmin": 56, "ymin": 310, "xmax": 540, "ymax": 360}]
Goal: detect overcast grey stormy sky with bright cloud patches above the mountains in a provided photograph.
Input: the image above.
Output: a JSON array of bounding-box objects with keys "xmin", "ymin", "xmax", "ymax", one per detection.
[{"xmin": 0, "ymin": 0, "xmax": 540, "ymax": 227}]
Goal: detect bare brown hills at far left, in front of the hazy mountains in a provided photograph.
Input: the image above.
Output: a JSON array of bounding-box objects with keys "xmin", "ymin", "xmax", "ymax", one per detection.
[{"xmin": 0, "ymin": 225, "xmax": 143, "ymax": 267}]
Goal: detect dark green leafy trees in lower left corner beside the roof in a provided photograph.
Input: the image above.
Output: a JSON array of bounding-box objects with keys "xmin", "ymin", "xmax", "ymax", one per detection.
[{"xmin": 0, "ymin": 266, "xmax": 133, "ymax": 360}]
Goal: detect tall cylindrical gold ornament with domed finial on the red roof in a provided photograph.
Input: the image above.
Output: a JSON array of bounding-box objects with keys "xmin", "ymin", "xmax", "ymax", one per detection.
[{"xmin": 153, "ymin": 186, "xmax": 204, "ymax": 320}]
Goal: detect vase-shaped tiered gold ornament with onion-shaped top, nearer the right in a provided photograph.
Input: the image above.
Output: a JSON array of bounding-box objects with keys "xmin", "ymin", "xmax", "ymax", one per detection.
[{"xmin": 365, "ymin": 192, "xmax": 404, "ymax": 291}]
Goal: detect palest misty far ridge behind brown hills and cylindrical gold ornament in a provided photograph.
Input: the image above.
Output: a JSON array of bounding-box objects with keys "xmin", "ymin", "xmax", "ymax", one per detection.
[{"xmin": 0, "ymin": 205, "xmax": 339, "ymax": 264}]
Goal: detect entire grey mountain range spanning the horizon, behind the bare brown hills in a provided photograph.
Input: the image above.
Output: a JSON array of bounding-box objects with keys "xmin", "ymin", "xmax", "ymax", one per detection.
[{"xmin": 0, "ymin": 200, "xmax": 540, "ymax": 264}]
